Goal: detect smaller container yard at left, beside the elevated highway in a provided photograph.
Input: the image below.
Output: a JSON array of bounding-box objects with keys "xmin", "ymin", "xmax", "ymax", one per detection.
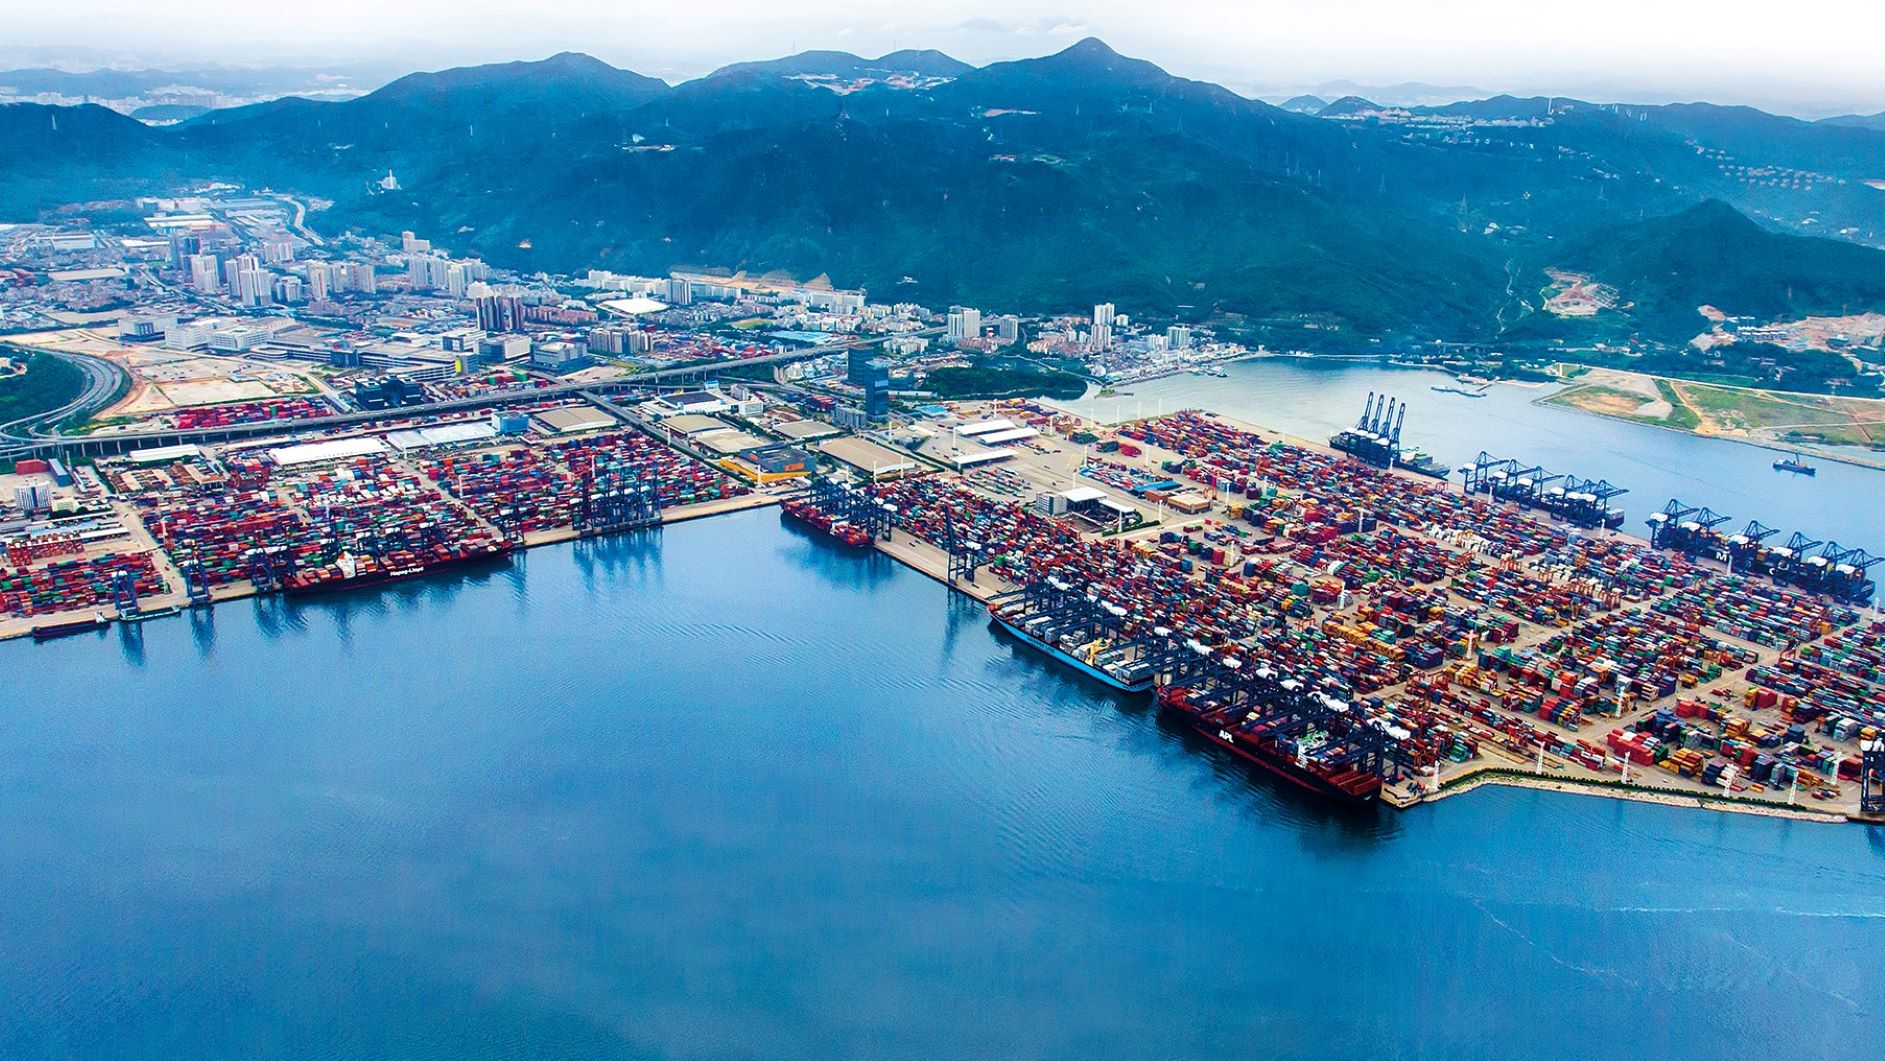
[{"xmin": 0, "ymin": 393, "xmax": 779, "ymax": 639}]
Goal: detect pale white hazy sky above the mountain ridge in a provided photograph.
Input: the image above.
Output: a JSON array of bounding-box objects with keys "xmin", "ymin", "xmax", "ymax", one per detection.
[{"xmin": 11, "ymin": 0, "xmax": 1885, "ymax": 111}]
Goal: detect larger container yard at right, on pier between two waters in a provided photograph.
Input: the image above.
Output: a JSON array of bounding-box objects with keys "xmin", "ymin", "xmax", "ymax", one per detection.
[{"xmin": 784, "ymin": 403, "xmax": 1885, "ymax": 818}]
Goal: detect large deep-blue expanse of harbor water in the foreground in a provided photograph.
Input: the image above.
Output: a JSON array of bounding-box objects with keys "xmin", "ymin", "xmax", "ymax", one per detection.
[{"xmin": 0, "ymin": 508, "xmax": 1885, "ymax": 1059}]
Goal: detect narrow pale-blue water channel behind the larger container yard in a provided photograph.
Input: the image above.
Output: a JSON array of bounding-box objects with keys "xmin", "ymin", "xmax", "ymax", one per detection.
[{"xmin": 1057, "ymin": 358, "xmax": 1885, "ymax": 554}]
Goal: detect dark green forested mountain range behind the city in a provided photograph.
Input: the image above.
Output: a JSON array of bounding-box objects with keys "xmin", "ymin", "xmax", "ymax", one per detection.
[{"xmin": 0, "ymin": 40, "xmax": 1885, "ymax": 343}]
